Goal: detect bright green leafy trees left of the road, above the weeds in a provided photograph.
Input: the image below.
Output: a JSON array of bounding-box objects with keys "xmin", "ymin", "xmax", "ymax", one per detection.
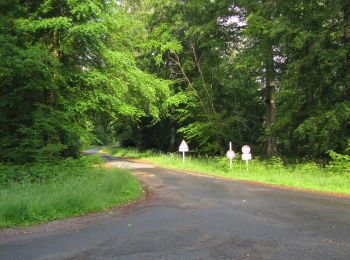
[{"xmin": 0, "ymin": 0, "xmax": 168, "ymax": 162}]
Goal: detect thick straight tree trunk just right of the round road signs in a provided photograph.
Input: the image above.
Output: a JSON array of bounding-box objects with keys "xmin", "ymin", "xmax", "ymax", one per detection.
[{"xmin": 265, "ymin": 44, "xmax": 277, "ymax": 157}]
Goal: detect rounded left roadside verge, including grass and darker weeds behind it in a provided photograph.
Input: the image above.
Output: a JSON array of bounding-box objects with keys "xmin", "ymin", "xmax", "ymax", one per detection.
[{"xmin": 0, "ymin": 158, "xmax": 143, "ymax": 228}]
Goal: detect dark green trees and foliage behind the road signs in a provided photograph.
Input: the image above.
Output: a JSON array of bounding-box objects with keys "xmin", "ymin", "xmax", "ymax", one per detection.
[{"xmin": 124, "ymin": 0, "xmax": 350, "ymax": 159}]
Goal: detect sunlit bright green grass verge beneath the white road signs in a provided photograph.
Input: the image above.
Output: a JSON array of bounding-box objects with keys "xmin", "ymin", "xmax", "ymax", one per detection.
[{"xmin": 104, "ymin": 147, "xmax": 350, "ymax": 194}]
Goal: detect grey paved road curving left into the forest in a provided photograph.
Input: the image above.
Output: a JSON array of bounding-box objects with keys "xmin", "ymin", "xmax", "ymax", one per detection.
[{"xmin": 0, "ymin": 156, "xmax": 350, "ymax": 259}]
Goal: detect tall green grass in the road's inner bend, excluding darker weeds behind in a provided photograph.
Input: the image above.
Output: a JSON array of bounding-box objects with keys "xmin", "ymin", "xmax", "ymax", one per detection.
[{"xmin": 0, "ymin": 164, "xmax": 143, "ymax": 228}]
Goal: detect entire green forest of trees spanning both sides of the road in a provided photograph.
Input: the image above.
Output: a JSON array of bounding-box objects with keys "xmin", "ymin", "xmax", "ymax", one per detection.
[{"xmin": 0, "ymin": 0, "xmax": 350, "ymax": 162}]
